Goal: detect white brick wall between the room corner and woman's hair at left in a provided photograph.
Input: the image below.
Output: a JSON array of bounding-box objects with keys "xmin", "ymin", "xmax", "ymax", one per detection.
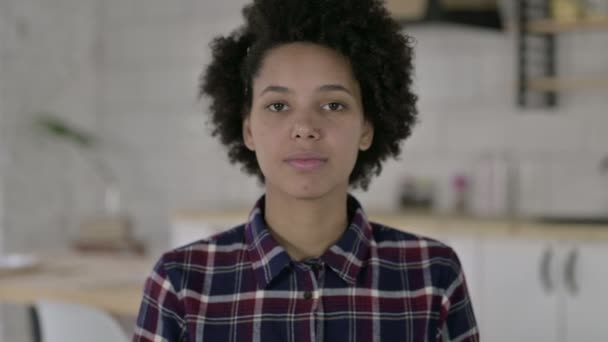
[{"xmin": 98, "ymin": 0, "xmax": 257, "ymax": 250}]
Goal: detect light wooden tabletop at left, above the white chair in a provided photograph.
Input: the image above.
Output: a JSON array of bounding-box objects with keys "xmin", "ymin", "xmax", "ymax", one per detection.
[{"xmin": 0, "ymin": 254, "xmax": 155, "ymax": 317}]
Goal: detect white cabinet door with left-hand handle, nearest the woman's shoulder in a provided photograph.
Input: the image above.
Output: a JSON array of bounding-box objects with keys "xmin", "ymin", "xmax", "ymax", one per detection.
[{"xmin": 480, "ymin": 238, "xmax": 563, "ymax": 342}]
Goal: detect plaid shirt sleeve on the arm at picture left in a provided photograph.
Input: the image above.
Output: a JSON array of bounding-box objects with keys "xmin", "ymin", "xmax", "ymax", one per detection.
[{"xmin": 132, "ymin": 256, "xmax": 186, "ymax": 342}]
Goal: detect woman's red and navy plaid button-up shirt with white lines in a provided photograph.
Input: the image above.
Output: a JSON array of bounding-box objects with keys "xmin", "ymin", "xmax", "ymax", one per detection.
[{"xmin": 133, "ymin": 195, "xmax": 479, "ymax": 342}]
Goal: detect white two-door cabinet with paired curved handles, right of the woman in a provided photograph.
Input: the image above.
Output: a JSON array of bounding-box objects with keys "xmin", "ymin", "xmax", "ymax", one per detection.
[{"xmin": 479, "ymin": 238, "xmax": 608, "ymax": 342}]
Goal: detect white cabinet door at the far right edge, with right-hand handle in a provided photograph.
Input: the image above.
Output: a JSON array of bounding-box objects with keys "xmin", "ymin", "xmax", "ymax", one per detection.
[{"xmin": 563, "ymin": 242, "xmax": 608, "ymax": 342}]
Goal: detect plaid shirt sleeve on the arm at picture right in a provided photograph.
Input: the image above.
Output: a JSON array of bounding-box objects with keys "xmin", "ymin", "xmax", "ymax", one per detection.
[{"xmin": 437, "ymin": 248, "xmax": 479, "ymax": 342}]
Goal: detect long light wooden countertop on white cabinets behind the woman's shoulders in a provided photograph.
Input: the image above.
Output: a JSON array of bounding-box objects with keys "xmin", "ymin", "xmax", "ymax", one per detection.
[{"xmin": 172, "ymin": 209, "xmax": 608, "ymax": 242}]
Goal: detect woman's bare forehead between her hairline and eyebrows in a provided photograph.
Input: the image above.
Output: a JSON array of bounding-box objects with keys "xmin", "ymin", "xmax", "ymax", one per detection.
[{"xmin": 253, "ymin": 42, "xmax": 358, "ymax": 93}]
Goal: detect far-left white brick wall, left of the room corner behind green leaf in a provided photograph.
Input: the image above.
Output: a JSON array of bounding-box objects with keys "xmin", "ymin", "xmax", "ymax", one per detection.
[{"xmin": 0, "ymin": 0, "xmax": 97, "ymax": 251}]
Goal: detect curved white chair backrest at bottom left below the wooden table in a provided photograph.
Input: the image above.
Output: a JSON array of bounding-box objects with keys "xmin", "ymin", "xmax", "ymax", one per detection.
[{"xmin": 35, "ymin": 300, "xmax": 128, "ymax": 342}]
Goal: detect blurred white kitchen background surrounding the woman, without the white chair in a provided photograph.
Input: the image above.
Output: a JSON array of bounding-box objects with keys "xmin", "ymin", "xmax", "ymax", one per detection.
[{"xmin": 0, "ymin": 0, "xmax": 608, "ymax": 342}]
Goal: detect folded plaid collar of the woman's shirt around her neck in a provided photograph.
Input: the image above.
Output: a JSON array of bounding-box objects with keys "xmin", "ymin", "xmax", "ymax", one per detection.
[{"xmin": 245, "ymin": 194, "xmax": 372, "ymax": 289}]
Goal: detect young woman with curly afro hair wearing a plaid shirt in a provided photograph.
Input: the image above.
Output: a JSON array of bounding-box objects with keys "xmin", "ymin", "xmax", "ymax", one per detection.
[{"xmin": 133, "ymin": 0, "xmax": 479, "ymax": 342}]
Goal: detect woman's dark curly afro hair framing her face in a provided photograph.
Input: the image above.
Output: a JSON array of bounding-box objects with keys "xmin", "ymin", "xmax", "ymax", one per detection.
[{"xmin": 199, "ymin": 0, "xmax": 418, "ymax": 190}]
